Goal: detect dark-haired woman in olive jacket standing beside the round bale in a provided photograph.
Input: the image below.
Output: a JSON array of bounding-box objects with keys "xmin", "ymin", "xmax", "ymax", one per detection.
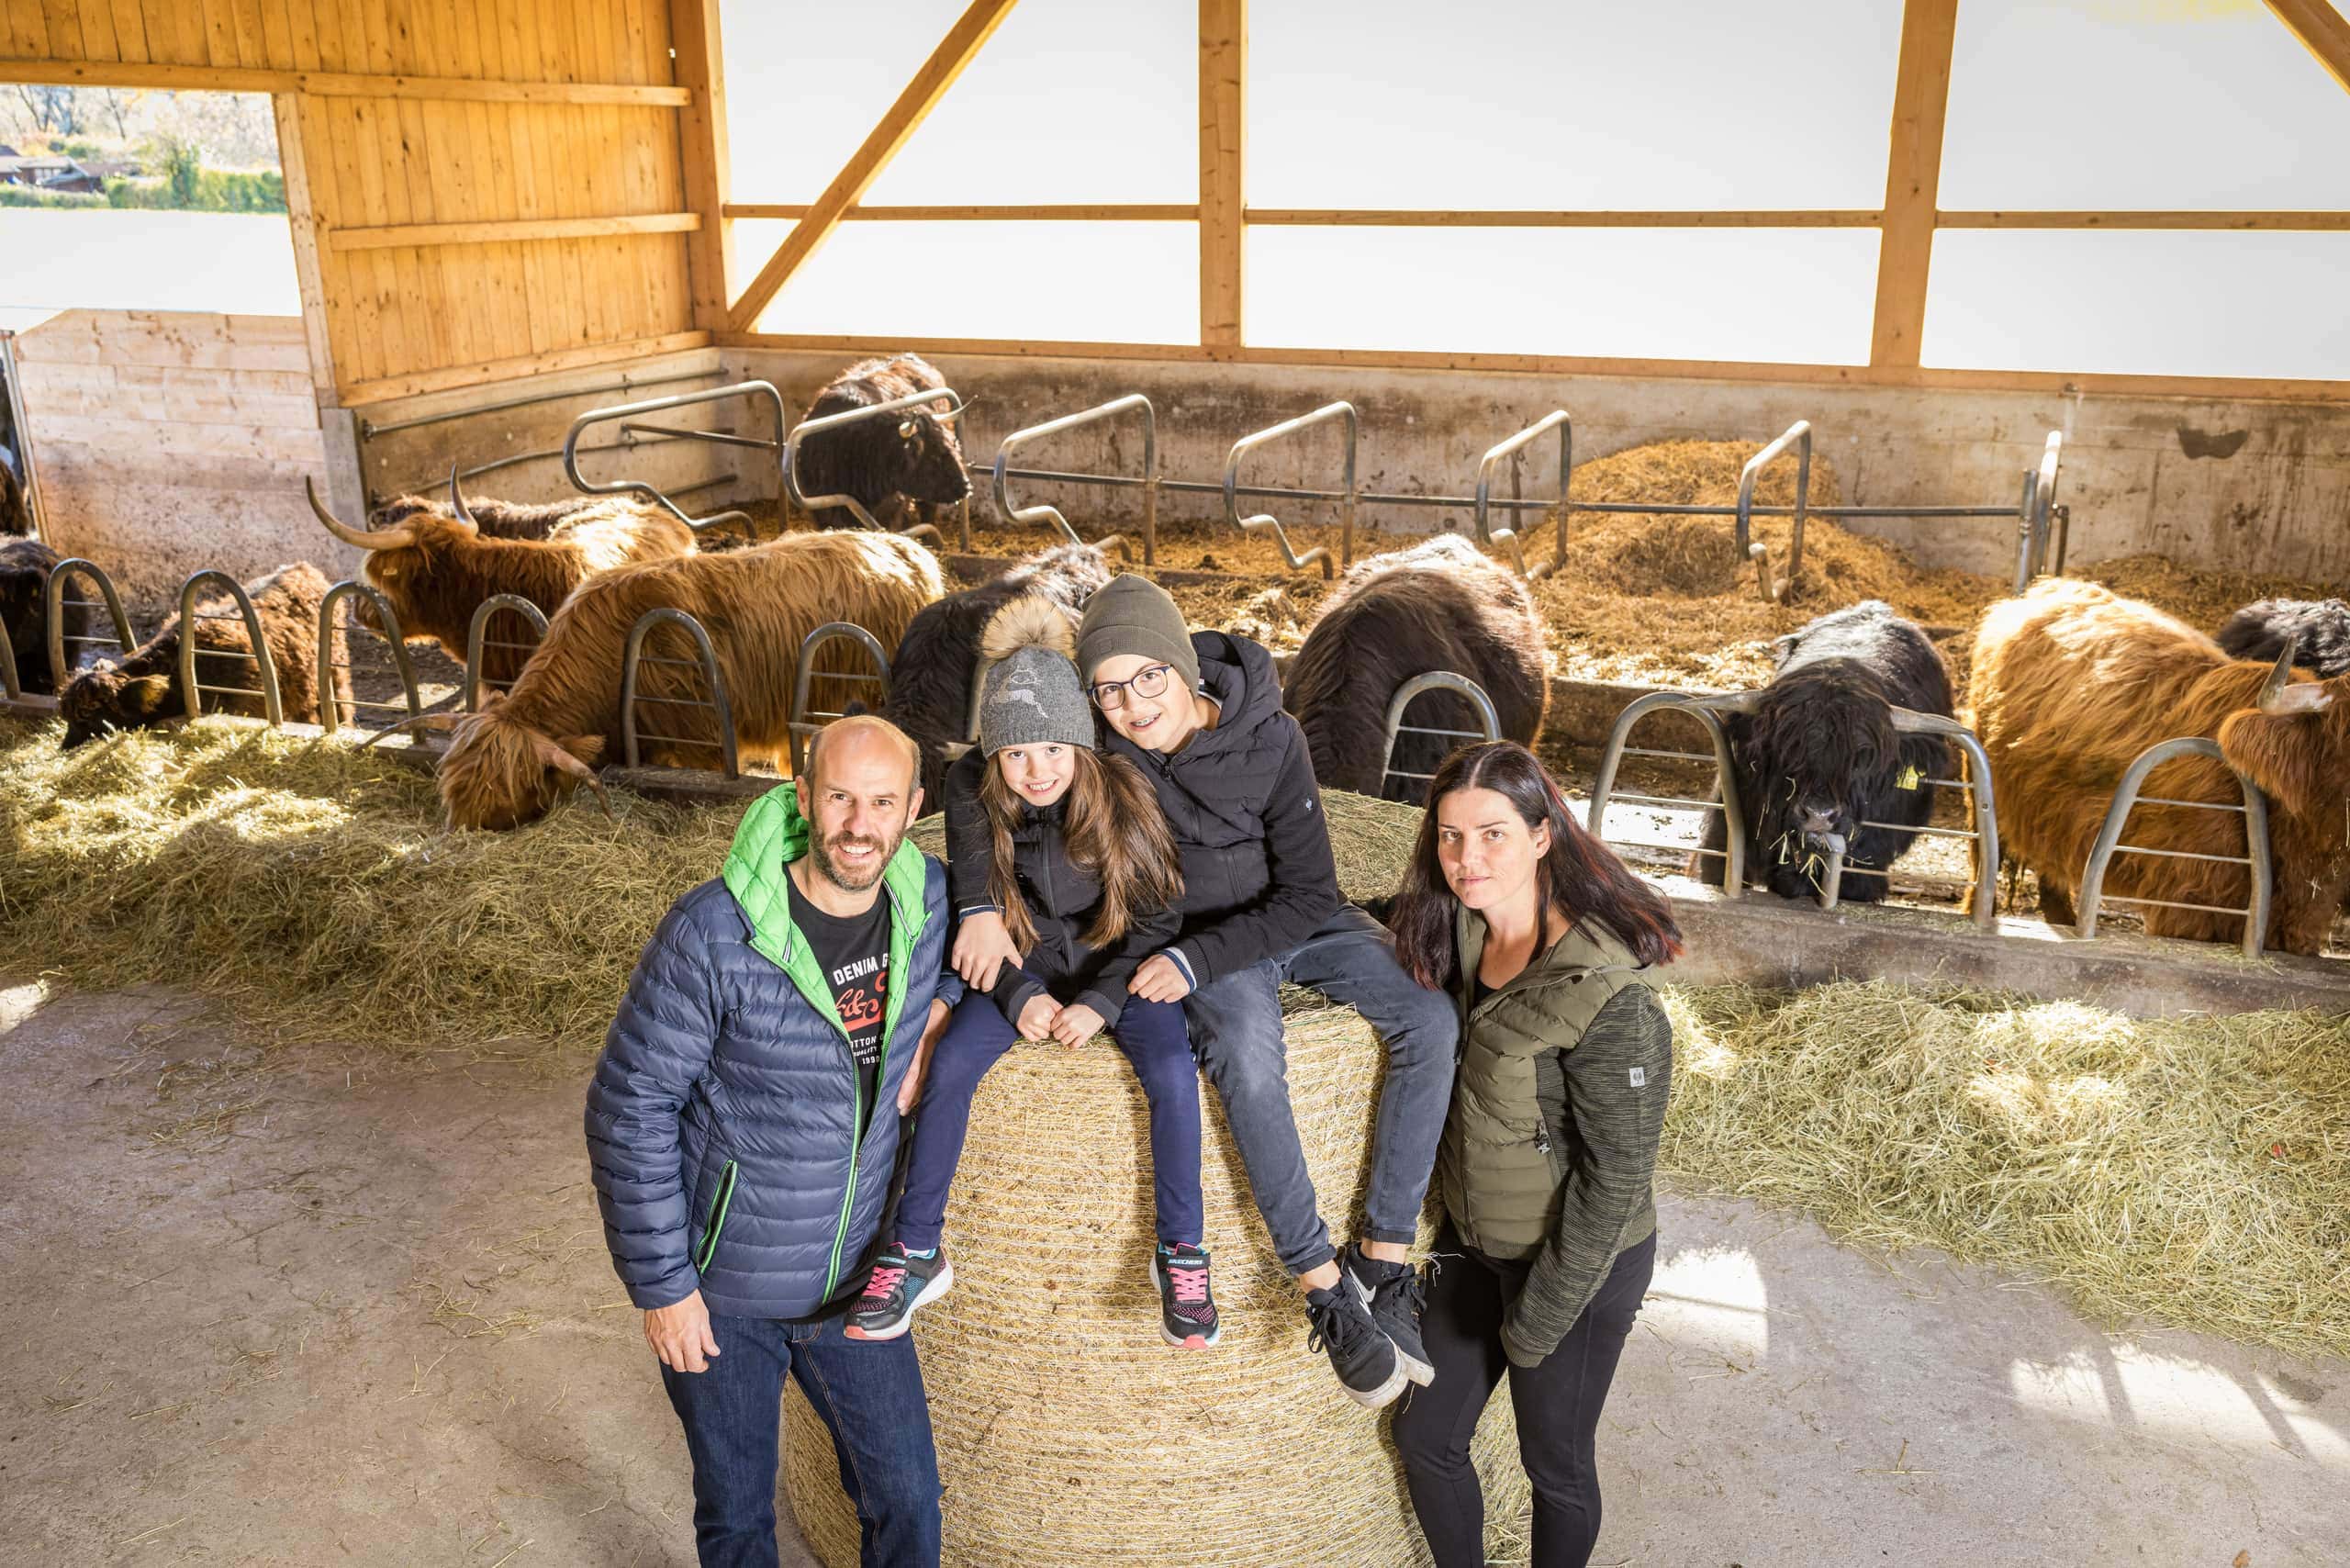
[{"xmin": 1389, "ymin": 741, "xmax": 1680, "ymax": 1568}]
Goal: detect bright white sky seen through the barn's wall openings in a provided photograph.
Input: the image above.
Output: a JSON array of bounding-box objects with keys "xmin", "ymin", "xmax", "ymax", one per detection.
[{"xmin": 0, "ymin": 0, "xmax": 2350, "ymax": 378}]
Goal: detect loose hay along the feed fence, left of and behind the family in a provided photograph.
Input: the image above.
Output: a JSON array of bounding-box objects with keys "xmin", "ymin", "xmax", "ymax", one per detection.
[{"xmin": 0, "ymin": 720, "xmax": 1417, "ymax": 1060}]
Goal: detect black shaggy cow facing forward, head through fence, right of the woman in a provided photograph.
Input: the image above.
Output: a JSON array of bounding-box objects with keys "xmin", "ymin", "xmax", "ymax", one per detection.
[{"xmin": 1699, "ymin": 599, "xmax": 1953, "ymax": 902}]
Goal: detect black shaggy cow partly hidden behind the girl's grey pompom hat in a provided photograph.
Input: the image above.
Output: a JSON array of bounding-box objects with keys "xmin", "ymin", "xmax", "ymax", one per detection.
[{"xmin": 881, "ymin": 545, "xmax": 1109, "ymax": 811}]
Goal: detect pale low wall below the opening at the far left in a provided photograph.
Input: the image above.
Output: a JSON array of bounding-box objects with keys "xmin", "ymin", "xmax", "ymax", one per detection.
[{"xmin": 17, "ymin": 310, "xmax": 345, "ymax": 618}]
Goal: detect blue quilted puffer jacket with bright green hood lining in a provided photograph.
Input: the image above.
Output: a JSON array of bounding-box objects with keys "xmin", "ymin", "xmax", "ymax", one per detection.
[{"xmin": 588, "ymin": 785, "xmax": 964, "ymax": 1319}]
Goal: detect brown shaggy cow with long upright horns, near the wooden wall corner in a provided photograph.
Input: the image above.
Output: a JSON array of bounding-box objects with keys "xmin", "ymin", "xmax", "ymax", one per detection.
[{"xmin": 303, "ymin": 479, "xmax": 693, "ymax": 687}]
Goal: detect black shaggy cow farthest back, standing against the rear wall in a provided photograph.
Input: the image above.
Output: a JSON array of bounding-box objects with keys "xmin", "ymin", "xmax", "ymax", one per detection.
[{"xmin": 797, "ymin": 355, "xmax": 970, "ymax": 532}]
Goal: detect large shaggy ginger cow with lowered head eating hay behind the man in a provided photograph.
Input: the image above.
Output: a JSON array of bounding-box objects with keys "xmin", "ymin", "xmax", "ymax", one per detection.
[{"xmin": 440, "ymin": 532, "xmax": 945, "ymax": 830}]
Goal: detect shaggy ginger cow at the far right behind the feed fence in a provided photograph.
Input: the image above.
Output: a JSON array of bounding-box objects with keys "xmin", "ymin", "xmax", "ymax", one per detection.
[{"xmin": 1972, "ymin": 578, "xmax": 2350, "ymax": 952}]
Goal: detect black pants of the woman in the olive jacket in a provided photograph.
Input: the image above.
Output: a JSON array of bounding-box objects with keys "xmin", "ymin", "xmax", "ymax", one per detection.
[{"xmin": 1393, "ymin": 1225, "xmax": 1657, "ymax": 1568}]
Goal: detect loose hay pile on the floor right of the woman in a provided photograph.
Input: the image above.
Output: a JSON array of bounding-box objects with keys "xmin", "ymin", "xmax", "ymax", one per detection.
[{"xmin": 1662, "ymin": 982, "xmax": 2350, "ymax": 1357}]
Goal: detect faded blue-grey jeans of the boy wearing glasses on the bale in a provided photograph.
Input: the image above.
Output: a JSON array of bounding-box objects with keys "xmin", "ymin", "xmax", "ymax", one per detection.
[{"xmin": 1184, "ymin": 902, "xmax": 1460, "ymax": 1274}]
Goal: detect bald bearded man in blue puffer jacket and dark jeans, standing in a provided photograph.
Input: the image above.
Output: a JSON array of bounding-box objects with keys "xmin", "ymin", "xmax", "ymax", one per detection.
[{"xmin": 588, "ymin": 717, "xmax": 964, "ymax": 1568}]
